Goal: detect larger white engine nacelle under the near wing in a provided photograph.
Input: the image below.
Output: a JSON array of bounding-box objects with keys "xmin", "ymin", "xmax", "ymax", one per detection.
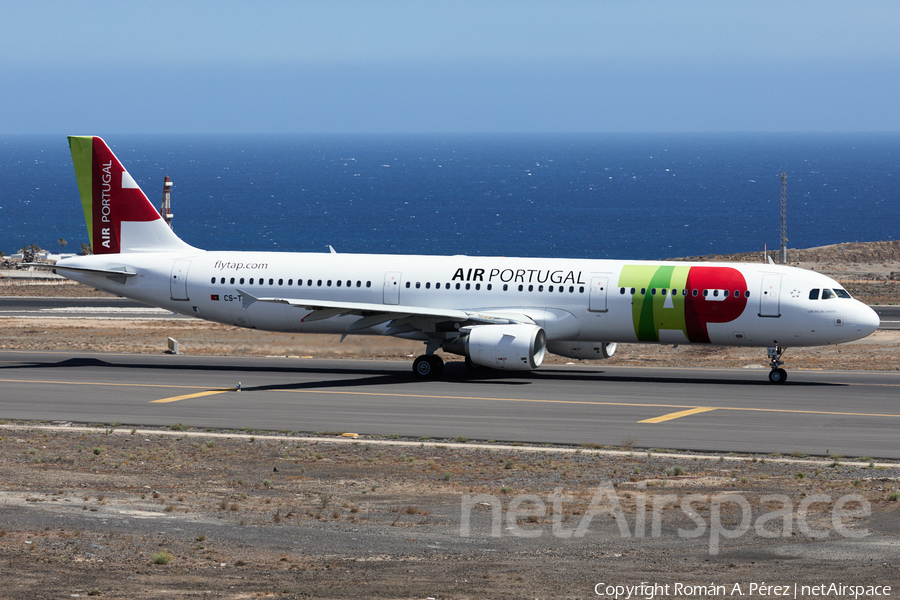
[{"xmin": 465, "ymin": 324, "xmax": 547, "ymax": 371}]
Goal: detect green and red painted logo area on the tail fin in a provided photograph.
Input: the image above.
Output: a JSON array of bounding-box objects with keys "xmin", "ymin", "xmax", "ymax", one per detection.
[{"xmin": 69, "ymin": 136, "xmax": 161, "ymax": 254}]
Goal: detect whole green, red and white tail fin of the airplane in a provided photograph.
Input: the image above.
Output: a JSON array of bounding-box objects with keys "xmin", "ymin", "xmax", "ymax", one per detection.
[{"xmin": 69, "ymin": 136, "xmax": 193, "ymax": 254}]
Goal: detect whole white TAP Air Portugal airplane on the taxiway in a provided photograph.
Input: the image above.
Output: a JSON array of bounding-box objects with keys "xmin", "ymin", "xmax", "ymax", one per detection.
[{"xmin": 44, "ymin": 136, "xmax": 880, "ymax": 384}]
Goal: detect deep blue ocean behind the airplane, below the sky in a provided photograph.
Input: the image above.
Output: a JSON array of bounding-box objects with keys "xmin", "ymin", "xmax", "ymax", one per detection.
[{"xmin": 0, "ymin": 134, "xmax": 900, "ymax": 259}]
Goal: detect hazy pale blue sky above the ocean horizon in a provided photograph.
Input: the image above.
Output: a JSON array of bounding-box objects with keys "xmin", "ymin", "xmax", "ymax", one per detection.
[{"xmin": 0, "ymin": 0, "xmax": 900, "ymax": 135}]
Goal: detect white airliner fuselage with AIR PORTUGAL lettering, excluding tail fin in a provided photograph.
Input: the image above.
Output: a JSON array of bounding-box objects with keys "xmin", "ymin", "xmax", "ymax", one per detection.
[{"xmin": 59, "ymin": 250, "xmax": 879, "ymax": 347}]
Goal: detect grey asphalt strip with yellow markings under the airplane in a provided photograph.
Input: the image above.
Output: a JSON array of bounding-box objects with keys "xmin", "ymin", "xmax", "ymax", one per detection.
[{"xmin": 0, "ymin": 351, "xmax": 900, "ymax": 458}]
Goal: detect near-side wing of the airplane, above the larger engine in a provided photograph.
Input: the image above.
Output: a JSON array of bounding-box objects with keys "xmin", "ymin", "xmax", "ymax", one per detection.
[{"xmin": 237, "ymin": 289, "xmax": 530, "ymax": 335}]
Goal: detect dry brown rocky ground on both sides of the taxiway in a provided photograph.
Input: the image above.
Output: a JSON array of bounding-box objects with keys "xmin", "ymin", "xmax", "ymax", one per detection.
[{"xmin": 0, "ymin": 242, "xmax": 900, "ymax": 599}]
